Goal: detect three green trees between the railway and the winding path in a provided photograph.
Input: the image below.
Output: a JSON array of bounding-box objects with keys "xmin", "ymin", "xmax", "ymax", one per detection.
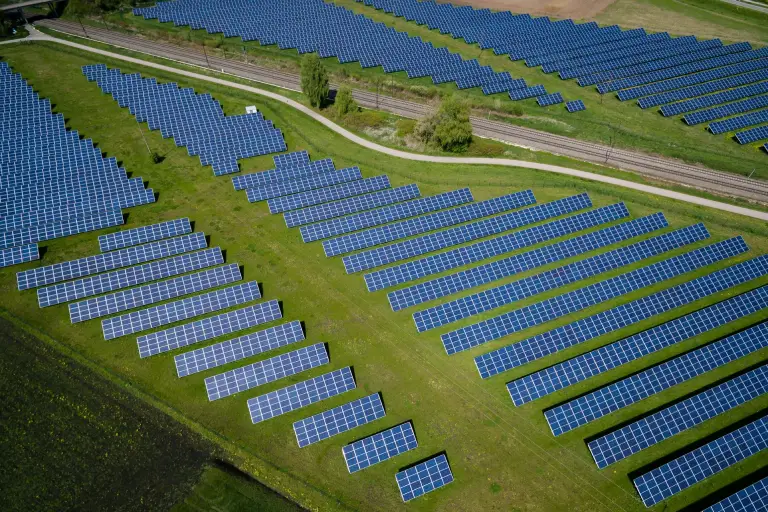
[{"xmin": 301, "ymin": 54, "xmax": 472, "ymax": 153}]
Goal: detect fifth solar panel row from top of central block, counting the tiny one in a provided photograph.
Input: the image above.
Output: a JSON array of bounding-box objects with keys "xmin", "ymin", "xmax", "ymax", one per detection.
[{"xmin": 285, "ymin": 184, "xmax": 421, "ymax": 228}]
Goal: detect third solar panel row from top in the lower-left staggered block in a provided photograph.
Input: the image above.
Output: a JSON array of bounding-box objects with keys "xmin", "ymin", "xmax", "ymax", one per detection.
[{"xmin": 37, "ymin": 247, "xmax": 224, "ymax": 308}]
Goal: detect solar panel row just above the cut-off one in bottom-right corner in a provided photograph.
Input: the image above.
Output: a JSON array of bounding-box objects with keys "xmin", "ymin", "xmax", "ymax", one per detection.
[{"xmin": 633, "ymin": 416, "xmax": 768, "ymax": 507}]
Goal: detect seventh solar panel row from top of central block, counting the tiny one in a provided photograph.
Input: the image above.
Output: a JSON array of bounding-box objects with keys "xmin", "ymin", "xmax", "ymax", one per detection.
[{"xmin": 323, "ymin": 190, "xmax": 536, "ymax": 256}]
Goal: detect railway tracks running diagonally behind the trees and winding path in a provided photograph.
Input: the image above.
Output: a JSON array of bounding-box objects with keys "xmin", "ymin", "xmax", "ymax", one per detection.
[{"xmin": 38, "ymin": 19, "xmax": 768, "ymax": 203}]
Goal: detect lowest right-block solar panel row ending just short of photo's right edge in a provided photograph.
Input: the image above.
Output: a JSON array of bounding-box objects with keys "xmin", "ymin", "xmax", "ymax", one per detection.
[{"xmin": 450, "ymin": 238, "xmax": 748, "ymax": 356}]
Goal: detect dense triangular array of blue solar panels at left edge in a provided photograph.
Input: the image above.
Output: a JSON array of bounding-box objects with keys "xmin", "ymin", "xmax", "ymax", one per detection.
[{"xmin": 0, "ymin": 62, "xmax": 155, "ymax": 267}]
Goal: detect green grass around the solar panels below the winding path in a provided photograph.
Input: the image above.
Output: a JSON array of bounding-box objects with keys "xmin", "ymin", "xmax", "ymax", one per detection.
[{"xmin": 0, "ymin": 44, "xmax": 768, "ymax": 511}]
